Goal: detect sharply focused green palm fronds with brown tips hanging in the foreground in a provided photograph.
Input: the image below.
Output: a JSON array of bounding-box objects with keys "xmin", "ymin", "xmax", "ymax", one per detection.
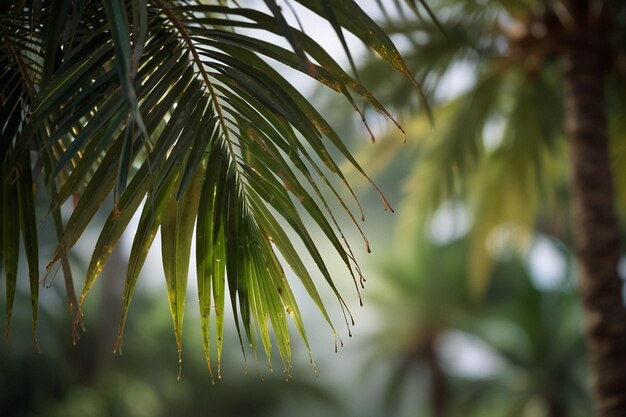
[{"xmin": 0, "ymin": 0, "xmax": 419, "ymax": 373}]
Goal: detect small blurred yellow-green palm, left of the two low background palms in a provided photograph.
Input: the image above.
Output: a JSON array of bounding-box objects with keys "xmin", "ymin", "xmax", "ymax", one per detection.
[{"xmin": 367, "ymin": 240, "xmax": 473, "ymax": 417}]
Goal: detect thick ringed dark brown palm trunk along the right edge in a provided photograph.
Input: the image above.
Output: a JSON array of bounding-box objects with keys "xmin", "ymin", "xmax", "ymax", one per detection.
[{"xmin": 564, "ymin": 33, "xmax": 626, "ymax": 417}]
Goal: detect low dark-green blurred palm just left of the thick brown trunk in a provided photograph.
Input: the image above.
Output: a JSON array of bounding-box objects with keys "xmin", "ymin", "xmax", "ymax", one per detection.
[{"xmin": 455, "ymin": 256, "xmax": 592, "ymax": 417}]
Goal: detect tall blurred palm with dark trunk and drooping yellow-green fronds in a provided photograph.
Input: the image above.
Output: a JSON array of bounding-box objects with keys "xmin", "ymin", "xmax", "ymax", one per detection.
[{"xmin": 352, "ymin": 0, "xmax": 626, "ymax": 417}]
